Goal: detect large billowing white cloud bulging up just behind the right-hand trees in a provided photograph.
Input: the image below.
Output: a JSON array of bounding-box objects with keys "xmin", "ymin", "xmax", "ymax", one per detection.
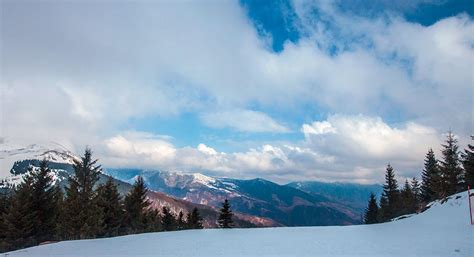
[{"xmin": 303, "ymin": 115, "xmax": 443, "ymax": 180}]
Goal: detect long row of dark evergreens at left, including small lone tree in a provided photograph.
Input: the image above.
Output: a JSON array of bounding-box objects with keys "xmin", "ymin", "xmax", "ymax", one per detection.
[{"xmin": 0, "ymin": 149, "xmax": 233, "ymax": 252}]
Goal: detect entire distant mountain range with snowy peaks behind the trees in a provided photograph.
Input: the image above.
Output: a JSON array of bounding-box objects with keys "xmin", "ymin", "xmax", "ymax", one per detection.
[{"xmin": 0, "ymin": 145, "xmax": 381, "ymax": 227}]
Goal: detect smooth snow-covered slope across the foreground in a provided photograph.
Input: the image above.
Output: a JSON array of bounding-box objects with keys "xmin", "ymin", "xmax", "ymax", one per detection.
[{"xmin": 2, "ymin": 192, "xmax": 474, "ymax": 257}]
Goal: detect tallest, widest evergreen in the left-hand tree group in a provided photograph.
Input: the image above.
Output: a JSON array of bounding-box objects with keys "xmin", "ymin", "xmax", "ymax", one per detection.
[{"xmin": 63, "ymin": 148, "xmax": 102, "ymax": 239}]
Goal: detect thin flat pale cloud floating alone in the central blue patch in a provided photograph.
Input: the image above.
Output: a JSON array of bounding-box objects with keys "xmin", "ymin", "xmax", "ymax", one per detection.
[{"xmin": 201, "ymin": 109, "xmax": 290, "ymax": 133}]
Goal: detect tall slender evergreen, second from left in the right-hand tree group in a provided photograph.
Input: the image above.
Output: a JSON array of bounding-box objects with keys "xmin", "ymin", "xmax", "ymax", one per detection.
[{"xmin": 380, "ymin": 164, "xmax": 399, "ymax": 221}]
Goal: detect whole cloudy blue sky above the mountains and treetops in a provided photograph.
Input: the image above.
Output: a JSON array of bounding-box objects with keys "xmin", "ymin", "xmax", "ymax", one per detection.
[{"xmin": 0, "ymin": 0, "xmax": 474, "ymax": 183}]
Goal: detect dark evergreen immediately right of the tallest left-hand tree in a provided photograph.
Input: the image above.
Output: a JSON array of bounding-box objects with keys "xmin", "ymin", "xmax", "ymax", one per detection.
[{"xmin": 97, "ymin": 177, "xmax": 124, "ymax": 237}]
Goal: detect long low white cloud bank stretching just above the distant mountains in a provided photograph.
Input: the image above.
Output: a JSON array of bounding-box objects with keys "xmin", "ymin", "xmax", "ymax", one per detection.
[{"xmin": 97, "ymin": 115, "xmax": 442, "ymax": 183}]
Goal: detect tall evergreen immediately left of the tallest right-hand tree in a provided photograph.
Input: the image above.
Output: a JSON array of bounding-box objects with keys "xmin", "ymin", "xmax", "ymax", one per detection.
[{"xmin": 421, "ymin": 149, "xmax": 441, "ymax": 202}]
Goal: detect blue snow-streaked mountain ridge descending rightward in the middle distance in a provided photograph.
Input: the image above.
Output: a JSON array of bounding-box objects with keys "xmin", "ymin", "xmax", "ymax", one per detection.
[{"xmin": 106, "ymin": 169, "xmax": 360, "ymax": 226}]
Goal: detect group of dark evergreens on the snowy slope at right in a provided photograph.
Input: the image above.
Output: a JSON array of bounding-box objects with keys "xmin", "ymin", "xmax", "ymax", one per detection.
[{"xmin": 364, "ymin": 131, "xmax": 474, "ymax": 224}]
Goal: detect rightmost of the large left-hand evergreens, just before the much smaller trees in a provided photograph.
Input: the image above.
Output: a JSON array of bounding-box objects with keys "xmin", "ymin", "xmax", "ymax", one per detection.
[{"xmin": 124, "ymin": 176, "xmax": 150, "ymax": 233}]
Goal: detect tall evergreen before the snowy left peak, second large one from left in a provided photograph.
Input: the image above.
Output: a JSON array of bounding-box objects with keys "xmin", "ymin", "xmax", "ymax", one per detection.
[{"xmin": 26, "ymin": 160, "xmax": 60, "ymax": 243}]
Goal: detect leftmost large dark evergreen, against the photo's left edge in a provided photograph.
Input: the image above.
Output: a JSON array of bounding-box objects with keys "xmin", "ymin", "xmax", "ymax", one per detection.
[{"xmin": 2, "ymin": 176, "xmax": 37, "ymax": 250}]
